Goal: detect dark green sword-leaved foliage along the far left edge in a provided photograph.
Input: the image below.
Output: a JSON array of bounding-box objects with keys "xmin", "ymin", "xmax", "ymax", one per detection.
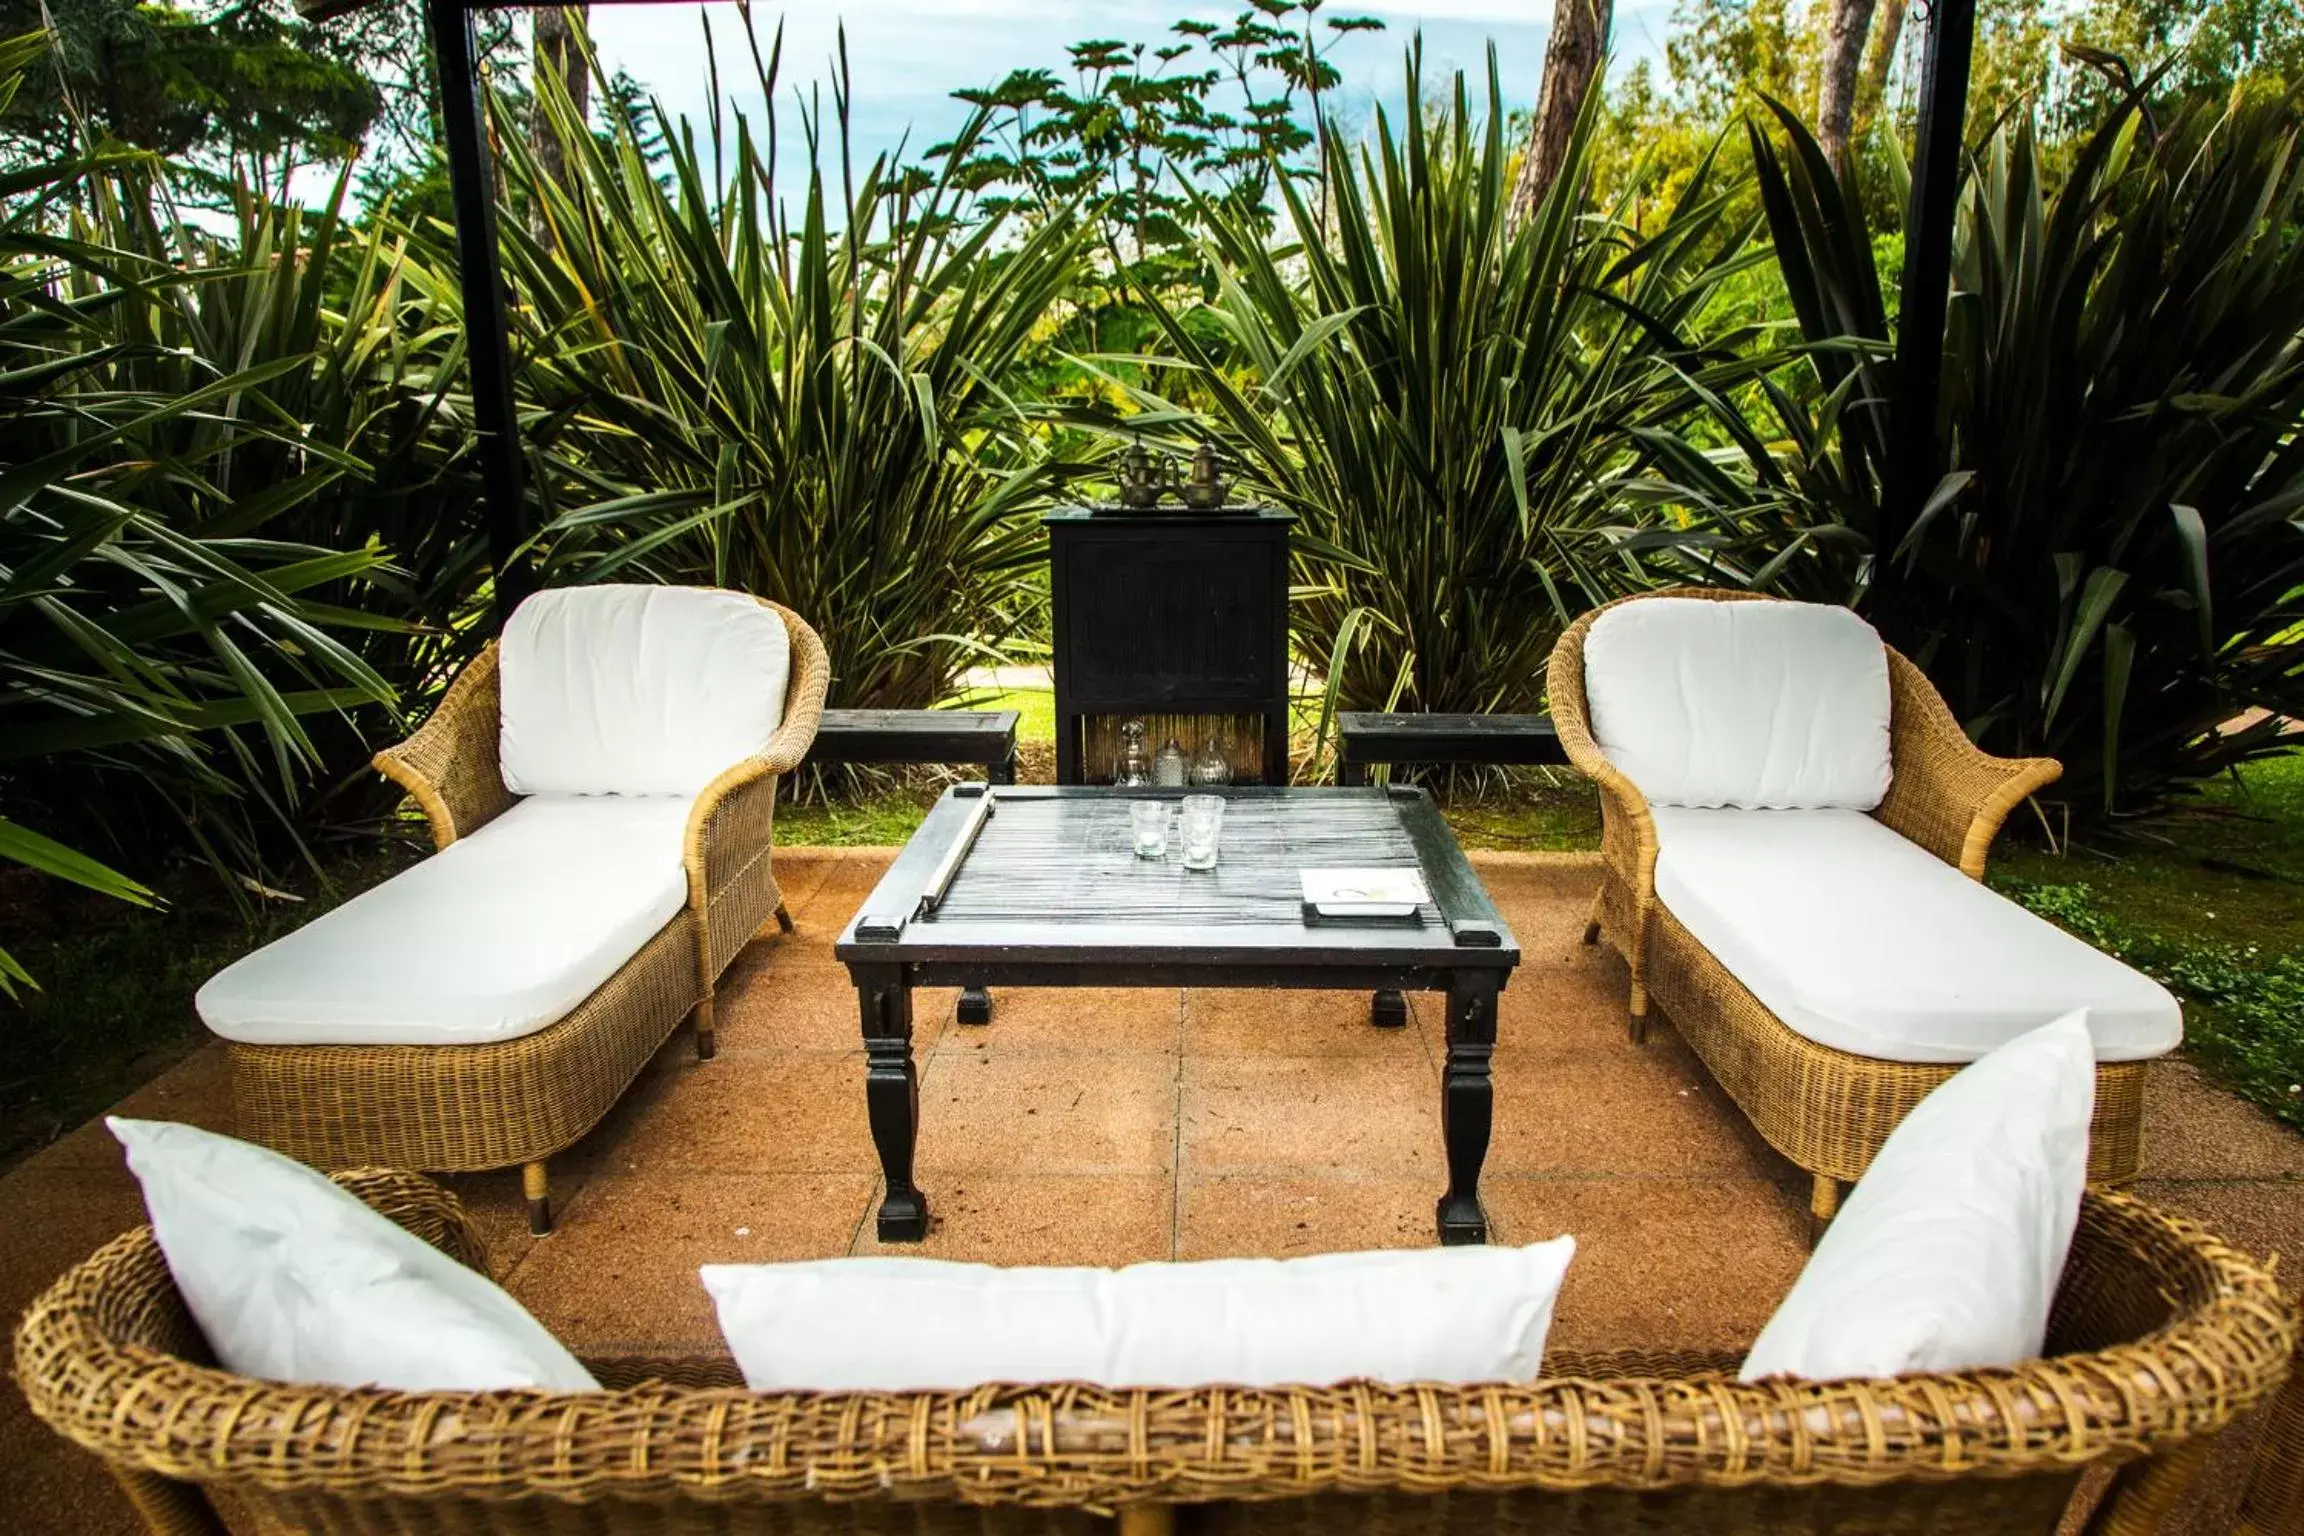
[{"xmin": 0, "ymin": 37, "xmax": 470, "ymax": 981}]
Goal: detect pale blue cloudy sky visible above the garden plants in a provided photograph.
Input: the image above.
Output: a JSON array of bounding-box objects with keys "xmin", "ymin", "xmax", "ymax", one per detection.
[{"xmin": 592, "ymin": 0, "xmax": 1670, "ymax": 178}]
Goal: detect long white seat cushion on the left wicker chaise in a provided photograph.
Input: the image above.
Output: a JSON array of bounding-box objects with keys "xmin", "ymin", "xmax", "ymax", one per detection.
[{"xmin": 194, "ymin": 797, "xmax": 694, "ymax": 1045}]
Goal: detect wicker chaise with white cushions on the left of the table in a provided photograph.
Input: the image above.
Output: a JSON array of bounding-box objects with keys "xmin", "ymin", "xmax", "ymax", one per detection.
[{"xmin": 200, "ymin": 587, "xmax": 829, "ymax": 1234}]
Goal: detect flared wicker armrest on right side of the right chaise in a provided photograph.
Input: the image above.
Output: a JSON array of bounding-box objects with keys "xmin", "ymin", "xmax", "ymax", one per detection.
[{"xmin": 1875, "ymin": 649, "xmax": 2064, "ymax": 880}]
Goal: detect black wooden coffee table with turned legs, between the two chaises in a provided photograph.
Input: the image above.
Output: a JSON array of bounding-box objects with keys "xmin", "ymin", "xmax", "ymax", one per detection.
[{"xmin": 834, "ymin": 785, "xmax": 1521, "ymax": 1244}]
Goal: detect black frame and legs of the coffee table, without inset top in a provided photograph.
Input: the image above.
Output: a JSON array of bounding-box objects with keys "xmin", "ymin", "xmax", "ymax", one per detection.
[{"xmin": 834, "ymin": 785, "xmax": 1521, "ymax": 1244}]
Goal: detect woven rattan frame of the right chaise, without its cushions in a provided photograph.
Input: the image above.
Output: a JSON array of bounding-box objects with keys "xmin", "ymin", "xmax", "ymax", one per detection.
[{"xmin": 1548, "ymin": 587, "xmax": 2145, "ymax": 1221}]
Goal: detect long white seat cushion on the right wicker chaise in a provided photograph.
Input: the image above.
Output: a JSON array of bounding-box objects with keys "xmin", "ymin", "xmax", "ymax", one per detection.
[{"xmin": 1652, "ymin": 806, "xmax": 2184, "ymax": 1062}]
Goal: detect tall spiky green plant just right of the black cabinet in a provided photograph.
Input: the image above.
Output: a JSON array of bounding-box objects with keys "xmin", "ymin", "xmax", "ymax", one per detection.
[{"xmin": 1115, "ymin": 51, "xmax": 1751, "ymax": 709}]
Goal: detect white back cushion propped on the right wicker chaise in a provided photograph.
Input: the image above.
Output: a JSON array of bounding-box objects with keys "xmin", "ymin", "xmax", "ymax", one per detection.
[{"xmin": 1585, "ymin": 596, "xmax": 1889, "ymax": 811}]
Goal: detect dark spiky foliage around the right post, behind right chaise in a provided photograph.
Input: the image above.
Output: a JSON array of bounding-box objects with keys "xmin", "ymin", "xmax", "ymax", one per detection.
[{"xmin": 1675, "ymin": 97, "xmax": 2304, "ymax": 811}]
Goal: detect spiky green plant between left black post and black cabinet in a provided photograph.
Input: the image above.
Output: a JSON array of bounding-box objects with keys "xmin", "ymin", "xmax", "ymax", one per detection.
[{"xmin": 505, "ymin": 31, "xmax": 1083, "ymax": 707}]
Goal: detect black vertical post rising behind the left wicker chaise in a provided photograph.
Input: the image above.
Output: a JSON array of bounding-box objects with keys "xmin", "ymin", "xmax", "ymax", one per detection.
[{"xmin": 424, "ymin": 0, "xmax": 537, "ymax": 629}]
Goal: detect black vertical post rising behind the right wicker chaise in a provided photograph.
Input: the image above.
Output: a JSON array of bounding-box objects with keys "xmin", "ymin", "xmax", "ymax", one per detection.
[{"xmin": 1873, "ymin": 0, "xmax": 1977, "ymax": 606}]
